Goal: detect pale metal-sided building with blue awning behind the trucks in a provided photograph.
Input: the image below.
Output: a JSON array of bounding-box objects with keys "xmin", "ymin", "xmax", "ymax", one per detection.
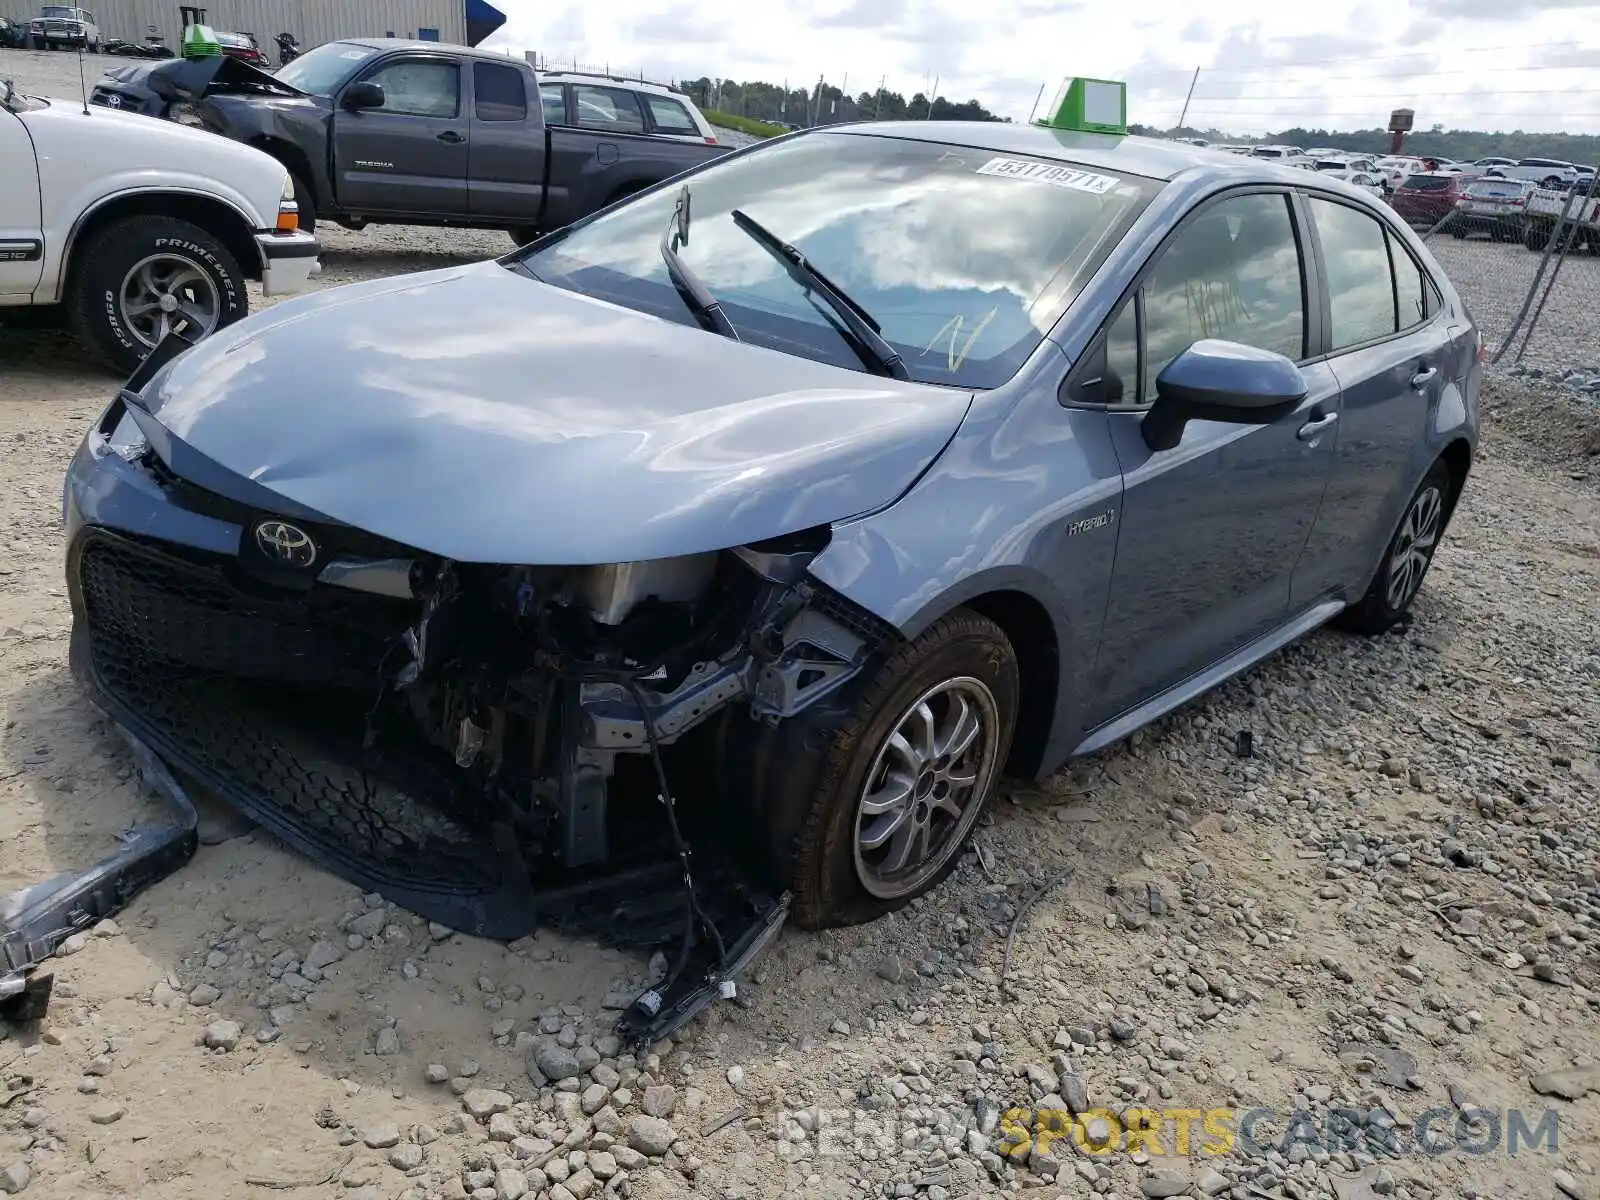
[{"xmin": 77, "ymin": 0, "xmax": 506, "ymax": 56}]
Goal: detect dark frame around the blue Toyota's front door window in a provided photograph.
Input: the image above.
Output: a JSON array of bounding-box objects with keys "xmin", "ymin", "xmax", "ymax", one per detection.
[{"xmin": 1056, "ymin": 184, "xmax": 1328, "ymax": 413}]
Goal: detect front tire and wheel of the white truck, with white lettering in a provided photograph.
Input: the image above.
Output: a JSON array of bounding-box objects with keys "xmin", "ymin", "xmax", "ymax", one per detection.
[{"xmin": 67, "ymin": 216, "xmax": 250, "ymax": 376}]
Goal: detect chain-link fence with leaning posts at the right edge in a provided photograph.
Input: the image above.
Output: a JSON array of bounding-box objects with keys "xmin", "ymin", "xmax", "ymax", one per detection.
[{"xmin": 1419, "ymin": 178, "xmax": 1600, "ymax": 380}]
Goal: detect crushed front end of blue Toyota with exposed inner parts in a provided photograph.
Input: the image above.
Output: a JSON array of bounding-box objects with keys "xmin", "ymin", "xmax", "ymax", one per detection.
[{"xmin": 64, "ymin": 392, "xmax": 894, "ymax": 1038}]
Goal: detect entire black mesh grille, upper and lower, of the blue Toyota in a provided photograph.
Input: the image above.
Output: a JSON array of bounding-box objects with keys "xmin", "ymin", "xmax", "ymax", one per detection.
[{"xmin": 78, "ymin": 533, "xmax": 501, "ymax": 896}]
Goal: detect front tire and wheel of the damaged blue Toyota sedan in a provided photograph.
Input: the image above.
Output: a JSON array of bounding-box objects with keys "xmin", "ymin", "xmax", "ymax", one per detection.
[{"xmin": 725, "ymin": 610, "xmax": 1019, "ymax": 930}]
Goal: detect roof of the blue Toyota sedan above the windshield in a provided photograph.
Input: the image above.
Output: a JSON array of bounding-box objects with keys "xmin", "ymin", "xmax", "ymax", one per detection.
[{"xmin": 819, "ymin": 122, "xmax": 1306, "ymax": 184}]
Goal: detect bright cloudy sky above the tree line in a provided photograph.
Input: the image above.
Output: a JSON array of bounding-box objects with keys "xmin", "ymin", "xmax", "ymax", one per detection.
[{"xmin": 488, "ymin": 0, "xmax": 1600, "ymax": 134}]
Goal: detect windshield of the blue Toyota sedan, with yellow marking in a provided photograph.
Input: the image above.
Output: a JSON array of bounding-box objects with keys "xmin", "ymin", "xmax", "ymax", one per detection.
[{"xmin": 515, "ymin": 133, "xmax": 1160, "ymax": 387}]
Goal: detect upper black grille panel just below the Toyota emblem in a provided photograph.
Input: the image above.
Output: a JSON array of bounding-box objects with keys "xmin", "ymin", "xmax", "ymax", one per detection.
[{"xmin": 78, "ymin": 536, "xmax": 414, "ymax": 693}]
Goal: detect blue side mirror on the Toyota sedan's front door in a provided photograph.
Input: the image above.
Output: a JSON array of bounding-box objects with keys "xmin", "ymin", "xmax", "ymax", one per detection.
[{"xmin": 1139, "ymin": 338, "xmax": 1309, "ymax": 450}]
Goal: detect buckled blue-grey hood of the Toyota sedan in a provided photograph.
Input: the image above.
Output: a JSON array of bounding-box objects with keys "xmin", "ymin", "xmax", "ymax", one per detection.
[{"xmin": 141, "ymin": 262, "xmax": 971, "ymax": 565}]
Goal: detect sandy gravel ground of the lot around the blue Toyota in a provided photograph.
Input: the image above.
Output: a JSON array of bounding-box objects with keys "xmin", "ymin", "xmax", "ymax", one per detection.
[{"xmin": 0, "ymin": 44, "xmax": 1600, "ymax": 1200}]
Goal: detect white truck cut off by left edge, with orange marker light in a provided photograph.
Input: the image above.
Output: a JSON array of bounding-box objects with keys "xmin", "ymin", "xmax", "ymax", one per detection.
[{"xmin": 0, "ymin": 82, "xmax": 317, "ymax": 374}]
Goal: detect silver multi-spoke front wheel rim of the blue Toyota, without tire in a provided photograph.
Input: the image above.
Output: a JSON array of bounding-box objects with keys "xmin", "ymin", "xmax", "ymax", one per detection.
[{"xmin": 854, "ymin": 675, "xmax": 1000, "ymax": 899}]
